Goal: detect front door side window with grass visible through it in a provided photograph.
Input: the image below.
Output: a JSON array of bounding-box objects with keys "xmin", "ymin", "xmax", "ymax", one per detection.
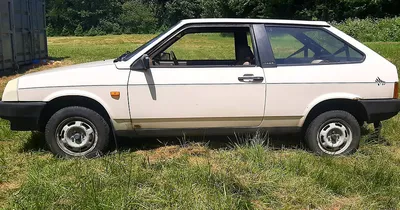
[{"xmin": 150, "ymin": 27, "xmax": 255, "ymax": 67}]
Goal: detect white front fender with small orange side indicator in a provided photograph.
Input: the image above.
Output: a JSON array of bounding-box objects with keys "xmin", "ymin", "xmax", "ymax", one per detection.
[{"xmin": 18, "ymin": 60, "xmax": 132, "ymax": 130}]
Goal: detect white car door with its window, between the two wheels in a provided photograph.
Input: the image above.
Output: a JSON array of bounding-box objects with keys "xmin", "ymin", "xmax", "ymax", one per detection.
[{"xmin": 128, "ymin": 25, "xmax": 265, "ymax": 130}]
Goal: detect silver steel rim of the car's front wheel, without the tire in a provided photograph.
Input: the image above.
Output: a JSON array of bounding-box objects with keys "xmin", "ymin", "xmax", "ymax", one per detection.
[{"xmin": 56, "ymin": 118, "xmax": 97, "ymax": 156}]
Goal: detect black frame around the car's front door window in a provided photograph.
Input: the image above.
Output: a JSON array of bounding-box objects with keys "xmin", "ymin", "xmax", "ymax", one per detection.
[{"xmin": 138, "ymin": 23, "xmax": 261, "ymax": 69}]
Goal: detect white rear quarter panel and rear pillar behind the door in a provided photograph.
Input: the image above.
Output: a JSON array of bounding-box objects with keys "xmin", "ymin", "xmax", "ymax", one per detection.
[{"xmin": 261, "ymin": 27, "xmax": 398, "ymax": 127}]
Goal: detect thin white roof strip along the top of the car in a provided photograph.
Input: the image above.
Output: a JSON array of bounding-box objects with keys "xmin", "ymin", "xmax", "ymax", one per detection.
[{"xmin": 181, "ymin": 18, "xmax": 330, "ymax": 26}]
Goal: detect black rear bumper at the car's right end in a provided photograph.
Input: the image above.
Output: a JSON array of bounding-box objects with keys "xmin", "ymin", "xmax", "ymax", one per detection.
[{"xmin": 360, "ymin": 99, "xmax": 400, "ymax": 123}]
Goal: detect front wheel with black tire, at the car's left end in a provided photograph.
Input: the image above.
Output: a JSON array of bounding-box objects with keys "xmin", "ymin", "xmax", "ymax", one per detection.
[{"xmin": 45, "ymin": 106, "xmax": 110, "ymax": 158}]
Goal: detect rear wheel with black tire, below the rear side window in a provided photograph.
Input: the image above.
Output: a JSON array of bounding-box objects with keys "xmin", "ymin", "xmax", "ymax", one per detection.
[{"xmin": 305, "ymin": 110, "xmax": 361, "ymax": 155}]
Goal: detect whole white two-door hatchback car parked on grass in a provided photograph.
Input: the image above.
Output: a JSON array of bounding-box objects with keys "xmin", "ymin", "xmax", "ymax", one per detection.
[{"xmin": 0, "ymin": 19, "xmax": 400, "ymax": 156}]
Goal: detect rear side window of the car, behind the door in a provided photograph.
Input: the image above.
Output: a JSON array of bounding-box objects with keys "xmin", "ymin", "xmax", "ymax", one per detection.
[{"xmin": 267, "ymin": 26, "xmax": 364, "ymax": 65}]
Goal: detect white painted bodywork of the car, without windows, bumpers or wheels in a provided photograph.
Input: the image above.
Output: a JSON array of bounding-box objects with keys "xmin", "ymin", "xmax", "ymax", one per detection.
[{"xmin": 2, "ymin": 19, "xmax": 398, "ymax": 135}]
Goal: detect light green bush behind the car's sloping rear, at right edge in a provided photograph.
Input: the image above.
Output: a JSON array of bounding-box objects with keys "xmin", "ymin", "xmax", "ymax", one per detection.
[{"xmin": 332, "ymin": 17, "xmax": 400, "ymax": 42}]
